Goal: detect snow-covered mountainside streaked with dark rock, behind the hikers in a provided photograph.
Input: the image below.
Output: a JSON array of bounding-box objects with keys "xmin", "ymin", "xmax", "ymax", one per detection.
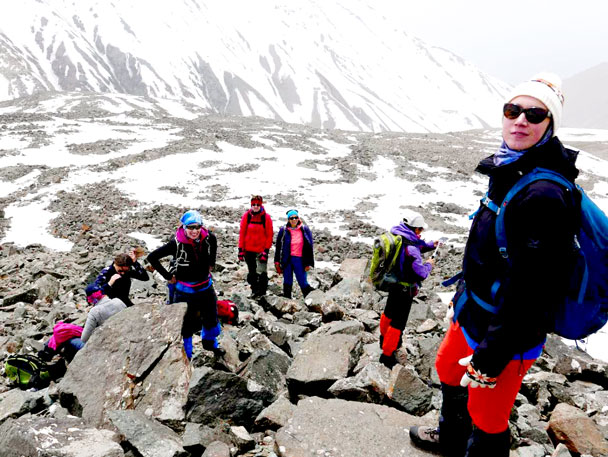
[{"xmin": 0, "ymin": 0, "xmax": 507, "ymax": 132}]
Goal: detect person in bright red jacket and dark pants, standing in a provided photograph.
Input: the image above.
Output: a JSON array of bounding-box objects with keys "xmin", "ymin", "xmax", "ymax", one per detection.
[{"xmin": 239, "ymin": 195, "xmax": 274, "ymax": 298}]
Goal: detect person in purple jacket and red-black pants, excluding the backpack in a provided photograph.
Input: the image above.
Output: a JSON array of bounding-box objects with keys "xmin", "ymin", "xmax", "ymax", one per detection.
[{"xmin": 380, "ymin": 216, "xmax": 438, "ymax": 368}]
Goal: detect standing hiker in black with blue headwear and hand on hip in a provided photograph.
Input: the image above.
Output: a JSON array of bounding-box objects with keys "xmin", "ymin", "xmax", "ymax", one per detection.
[{"xmin": 148, "ymin": 210, "xmax": 224, "ymax": 359}]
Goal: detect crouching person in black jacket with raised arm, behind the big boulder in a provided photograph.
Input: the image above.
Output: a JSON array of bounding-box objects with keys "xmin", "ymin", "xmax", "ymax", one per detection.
[{"xmin": 95, "ymin": 248, "xmax": 149, "ymax": 306}]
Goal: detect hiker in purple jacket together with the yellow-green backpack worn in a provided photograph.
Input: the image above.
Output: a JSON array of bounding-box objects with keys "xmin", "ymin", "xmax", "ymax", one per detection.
[{"xmin": 370, "ymin": 215, "xmax": 439, "ymax": 368}]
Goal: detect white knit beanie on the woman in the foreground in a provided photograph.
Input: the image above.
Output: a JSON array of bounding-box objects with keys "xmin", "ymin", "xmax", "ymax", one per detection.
[{"xmin": 507, "ymin": 72, "xmax": 564, "ymax": 135}]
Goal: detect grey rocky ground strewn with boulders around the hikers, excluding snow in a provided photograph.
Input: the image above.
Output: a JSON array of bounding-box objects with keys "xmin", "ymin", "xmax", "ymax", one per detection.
[{"xmin": 0, "ymin": 91, "xmax": 608, "ymax": 457}]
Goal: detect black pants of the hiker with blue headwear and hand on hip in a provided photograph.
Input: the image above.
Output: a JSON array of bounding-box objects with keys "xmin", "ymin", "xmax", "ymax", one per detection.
[{"xmin": 175, "ymin": 286, "xmax": 218, "ymax": 338}]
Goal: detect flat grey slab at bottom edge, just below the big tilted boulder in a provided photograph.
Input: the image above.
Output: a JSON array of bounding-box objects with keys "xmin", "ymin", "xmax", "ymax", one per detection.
[{"xmin": 108, "ymin": 410, "xmax": 189, "ymax": 457}]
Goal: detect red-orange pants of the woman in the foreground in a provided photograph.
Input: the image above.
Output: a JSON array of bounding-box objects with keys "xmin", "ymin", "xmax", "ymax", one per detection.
[{"xmin": 435, "ymin": 323, "xmax": 536, "ymax": 433}]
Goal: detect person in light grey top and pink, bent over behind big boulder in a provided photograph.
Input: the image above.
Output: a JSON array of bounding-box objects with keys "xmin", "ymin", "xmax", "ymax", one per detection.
[{"xmin": 38, "ymin": 284, "xmax": 127, "ymax": 361}]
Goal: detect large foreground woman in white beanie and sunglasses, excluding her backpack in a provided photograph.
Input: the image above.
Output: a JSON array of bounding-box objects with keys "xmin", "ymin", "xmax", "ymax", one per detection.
[{"xmin": 409, "ymin": 73, "xmax": 579, "ymax": 457}]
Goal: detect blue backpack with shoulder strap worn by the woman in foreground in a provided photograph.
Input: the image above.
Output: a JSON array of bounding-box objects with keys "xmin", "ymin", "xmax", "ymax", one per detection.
[{"xmin": 482, "ymin": 168, "xmax": 608, "ymax": 340}]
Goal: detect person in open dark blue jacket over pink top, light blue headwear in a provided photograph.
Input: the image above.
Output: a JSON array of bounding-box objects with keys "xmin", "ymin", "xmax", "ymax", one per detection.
[{"xmin": 274, "ymin": 209, "xmax": 315, "ymax": 298}]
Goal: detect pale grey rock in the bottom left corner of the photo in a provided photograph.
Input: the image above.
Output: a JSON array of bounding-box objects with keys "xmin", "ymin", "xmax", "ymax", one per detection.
[{"xmin": 0, "ymin": 416, "xmax": 124, "ymax": 457}]
